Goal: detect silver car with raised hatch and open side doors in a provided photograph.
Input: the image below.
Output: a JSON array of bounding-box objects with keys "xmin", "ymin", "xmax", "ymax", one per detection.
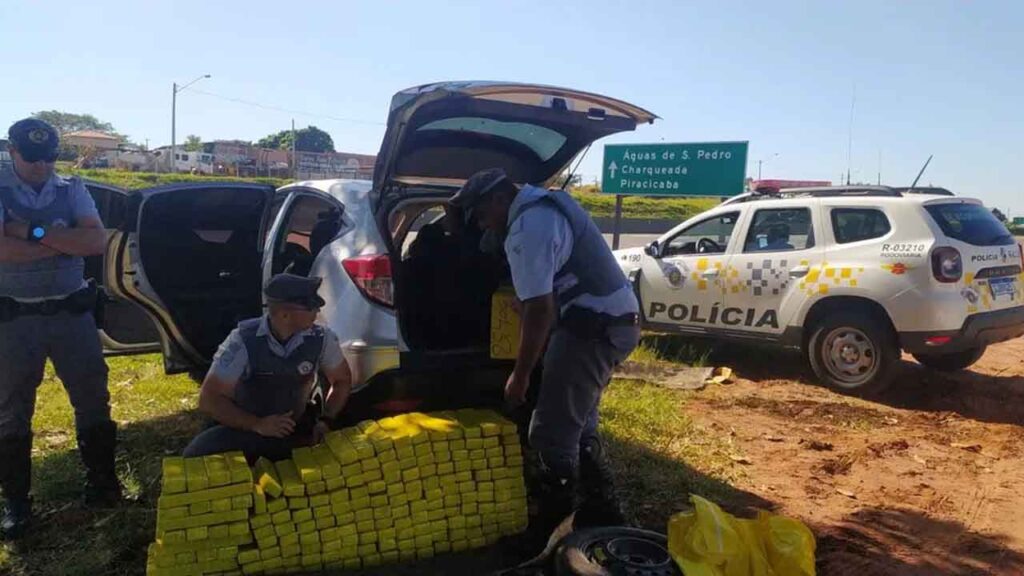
[{"xmin": 83, "ymin": 82, "xmax": 655, "ymax": 409}]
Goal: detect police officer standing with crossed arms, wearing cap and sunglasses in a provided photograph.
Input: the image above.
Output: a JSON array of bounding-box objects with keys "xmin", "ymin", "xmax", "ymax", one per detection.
[{"xmin": 0, "ymin": 118, "xmax": 121, "ymax": 539}]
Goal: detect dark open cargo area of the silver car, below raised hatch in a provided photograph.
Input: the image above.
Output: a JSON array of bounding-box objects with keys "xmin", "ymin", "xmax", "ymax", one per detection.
[{"xmin": 388, "ymin": 197, "xmax": 509, "ymax": 358}]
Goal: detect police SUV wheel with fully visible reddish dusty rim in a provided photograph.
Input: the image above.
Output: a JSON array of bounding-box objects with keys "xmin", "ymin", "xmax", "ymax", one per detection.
[{"xmin": 806, "ymin": 311, "xmax": 900, "ymax": 396}]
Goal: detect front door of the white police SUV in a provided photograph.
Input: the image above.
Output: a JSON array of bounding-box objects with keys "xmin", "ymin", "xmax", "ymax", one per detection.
[{"xmin": 638, "ymin": 208, "xmax": 742, "ymax": 333}]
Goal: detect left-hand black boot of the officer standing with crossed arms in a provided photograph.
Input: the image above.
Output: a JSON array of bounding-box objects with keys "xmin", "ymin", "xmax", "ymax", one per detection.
[{"xmin": 0, "ymin": 435, "xmax": 32, "ymax": 540}]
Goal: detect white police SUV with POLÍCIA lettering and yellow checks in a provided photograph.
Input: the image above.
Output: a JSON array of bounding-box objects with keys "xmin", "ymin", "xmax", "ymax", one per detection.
[{"xmin": 615, "ymin": 187, "xmax": 1024, "ymax": 394}]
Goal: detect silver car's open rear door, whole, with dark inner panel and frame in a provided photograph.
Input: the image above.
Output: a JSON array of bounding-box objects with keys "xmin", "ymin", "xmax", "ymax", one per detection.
[{"xmin": 105, "ymin": 182, "xmax": 273, "ymax": 373}]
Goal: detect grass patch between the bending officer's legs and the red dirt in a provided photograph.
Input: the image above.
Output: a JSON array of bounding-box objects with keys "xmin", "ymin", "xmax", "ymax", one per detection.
[{"xmin": 601, "ymin": 380, "xmax": 751, "ymax": 532}]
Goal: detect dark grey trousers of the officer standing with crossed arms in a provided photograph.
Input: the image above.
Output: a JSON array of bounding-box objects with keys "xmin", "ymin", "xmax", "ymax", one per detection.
[{"xmin": 0, "ymin": 312, "xmax": 111, "ymax": 438}]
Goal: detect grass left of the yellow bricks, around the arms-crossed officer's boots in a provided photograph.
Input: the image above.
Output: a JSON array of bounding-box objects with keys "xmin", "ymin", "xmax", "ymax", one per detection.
[{"xmin": 0, "ymin": 356, "xmax": 202, "ymax": 576}]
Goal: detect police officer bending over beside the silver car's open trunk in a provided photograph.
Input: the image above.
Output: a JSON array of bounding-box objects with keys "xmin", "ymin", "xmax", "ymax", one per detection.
[{"xmin": 451, "ymin": 168, "xmax": 640, "ymax": 539}]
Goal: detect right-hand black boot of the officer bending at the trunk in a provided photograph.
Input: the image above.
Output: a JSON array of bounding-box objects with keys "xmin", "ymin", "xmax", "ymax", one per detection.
[{"xmin": 574, "ymin": 436, "xmax": 626, "ymax": 528}]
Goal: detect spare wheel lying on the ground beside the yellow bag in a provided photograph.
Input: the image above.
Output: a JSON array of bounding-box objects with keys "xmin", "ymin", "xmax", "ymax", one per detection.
[{"xmin": 554, "ymin": 527, "xmax": 682, "ymax": 576}]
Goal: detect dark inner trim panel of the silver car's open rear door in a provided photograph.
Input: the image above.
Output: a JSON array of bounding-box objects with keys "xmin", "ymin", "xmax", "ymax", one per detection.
[{"xmin": 138, "ymin": 188, "xmax": 266, "ymax": 359}]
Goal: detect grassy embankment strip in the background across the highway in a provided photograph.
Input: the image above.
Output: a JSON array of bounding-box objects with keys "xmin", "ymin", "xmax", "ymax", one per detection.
[{"xmin": 66, "ymin": 165, "xmax": 718, "ymax": 221}]
